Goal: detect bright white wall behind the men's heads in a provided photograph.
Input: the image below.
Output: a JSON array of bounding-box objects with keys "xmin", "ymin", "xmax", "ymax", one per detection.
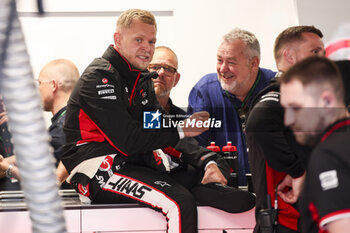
[{"xmin": 18, "ymin": 0, "xmax": 298, "ymax": 123}]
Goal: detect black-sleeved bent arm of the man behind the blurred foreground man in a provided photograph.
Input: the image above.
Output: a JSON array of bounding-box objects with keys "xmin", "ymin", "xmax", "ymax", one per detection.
[{"xmin": 246, "ymin": 101, "xmax": 306, "ymax": 178}]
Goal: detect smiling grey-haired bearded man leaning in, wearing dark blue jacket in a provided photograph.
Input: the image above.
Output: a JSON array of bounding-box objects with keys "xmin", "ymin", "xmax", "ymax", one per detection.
[{"xmin": 188, "ymin": 28, "xmax": 275, "ymax": 185}]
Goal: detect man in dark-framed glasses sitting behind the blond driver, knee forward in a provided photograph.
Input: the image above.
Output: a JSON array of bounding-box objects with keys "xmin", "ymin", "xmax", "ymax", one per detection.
[{"xmin": 148, "ymin": 46, "xmax": 255, "ymax": 213}]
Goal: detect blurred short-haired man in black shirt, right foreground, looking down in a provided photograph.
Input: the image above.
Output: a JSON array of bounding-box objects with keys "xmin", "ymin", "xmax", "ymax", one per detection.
[{"xmin": 279, "ymin": 57, "xmax": 350, "ymax": 233}]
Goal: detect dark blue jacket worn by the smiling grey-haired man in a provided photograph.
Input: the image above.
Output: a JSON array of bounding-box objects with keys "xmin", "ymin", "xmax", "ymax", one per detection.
[{"xmin": 187, "ymin": 68, "xmax": 276, "ymax": 185}]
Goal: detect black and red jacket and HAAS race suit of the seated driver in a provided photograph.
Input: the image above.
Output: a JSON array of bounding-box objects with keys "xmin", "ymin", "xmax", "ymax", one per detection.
[{"xmin": 62, "ymin": 46, "xmax": 216, "ymax": 232}]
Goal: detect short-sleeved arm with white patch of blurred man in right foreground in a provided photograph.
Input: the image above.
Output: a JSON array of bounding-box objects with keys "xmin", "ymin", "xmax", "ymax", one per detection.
[{"xmin": 307, "ymin": 147, "xmax": 350, "ymax": 233}]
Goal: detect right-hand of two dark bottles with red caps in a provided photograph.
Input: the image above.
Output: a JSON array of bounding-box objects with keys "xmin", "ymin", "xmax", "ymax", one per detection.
[{"xmin": 222, "ymin": 142, "xmax": 238, "ymax": 188}]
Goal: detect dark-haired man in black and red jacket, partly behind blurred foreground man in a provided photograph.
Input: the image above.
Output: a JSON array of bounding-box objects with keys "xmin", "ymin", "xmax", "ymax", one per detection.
[{"xmin": 246, "ymin": 26, "xmax": 324, "ymax": 232}]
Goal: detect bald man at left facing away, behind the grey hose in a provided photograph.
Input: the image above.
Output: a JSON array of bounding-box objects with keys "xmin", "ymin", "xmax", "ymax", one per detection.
[{"xmin": 0, "ymin": 59, "xmax": 79, "ymax": 189}]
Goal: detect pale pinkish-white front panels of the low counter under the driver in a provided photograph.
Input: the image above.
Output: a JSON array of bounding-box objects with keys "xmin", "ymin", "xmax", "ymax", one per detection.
[{"xmin": 0, "ymin": 206, "xmax": 255, "ymax": 233}]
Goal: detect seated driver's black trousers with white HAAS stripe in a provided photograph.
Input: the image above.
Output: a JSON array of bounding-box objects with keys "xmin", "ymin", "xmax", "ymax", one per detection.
[{"xmin": 89, "ymin": 163, "xmax": 198, "ymax": 233}]
